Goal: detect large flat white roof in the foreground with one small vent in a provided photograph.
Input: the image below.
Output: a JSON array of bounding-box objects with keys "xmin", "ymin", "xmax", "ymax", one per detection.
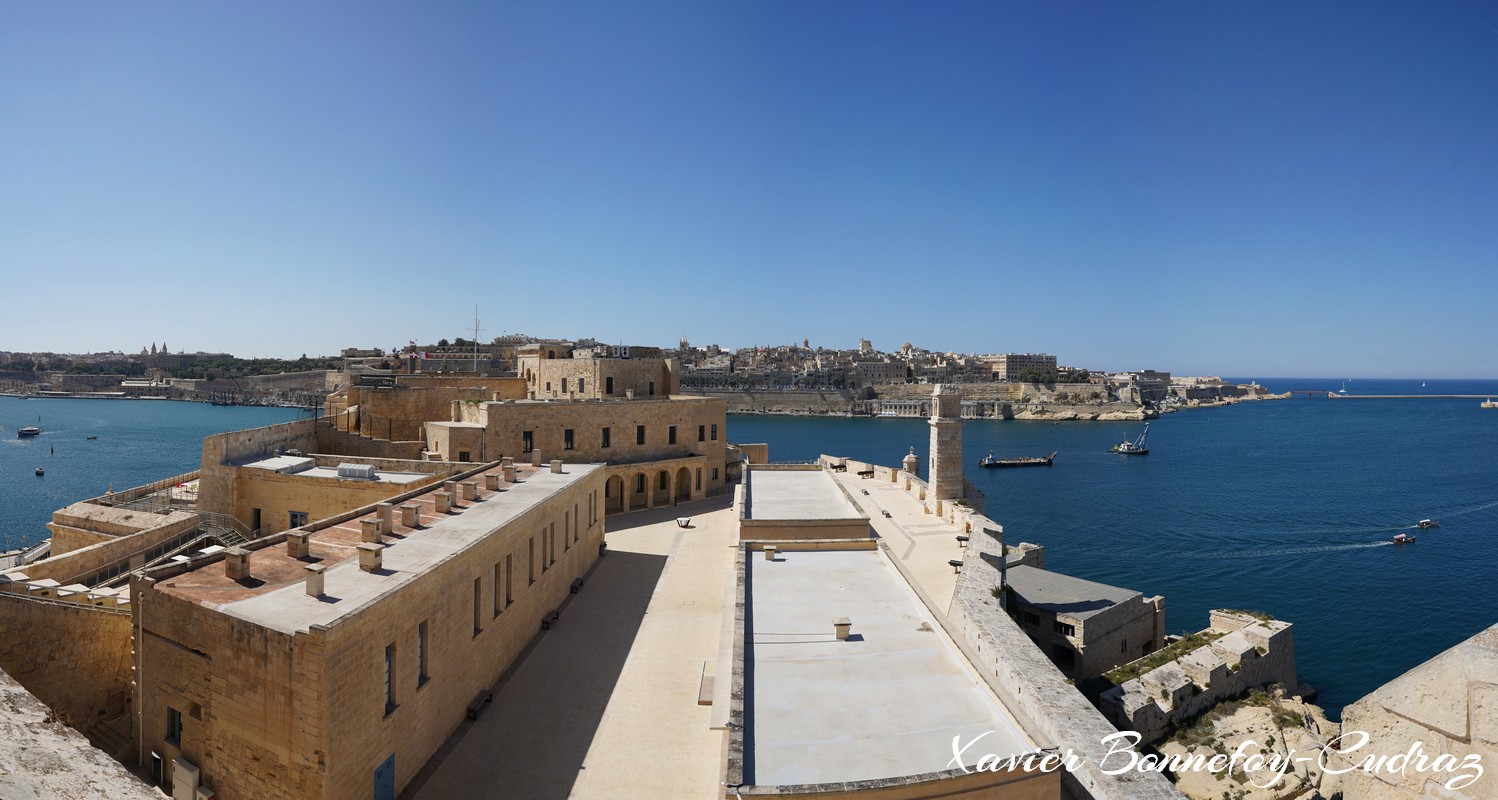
[{"xmin": 745, "ymin": 551, "xmax": 1035, "ymax": 785}]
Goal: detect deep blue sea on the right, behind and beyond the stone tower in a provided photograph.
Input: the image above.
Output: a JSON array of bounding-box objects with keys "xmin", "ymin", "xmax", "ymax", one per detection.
[{"xmin": 728, "ymin": 378, "xmax": 1498, "ymax": 715}]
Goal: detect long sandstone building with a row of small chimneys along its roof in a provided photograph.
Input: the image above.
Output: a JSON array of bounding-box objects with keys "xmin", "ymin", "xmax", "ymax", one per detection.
[{"xmin": 132, "ymin": 461, "xmax": 604, "ymax": 800}]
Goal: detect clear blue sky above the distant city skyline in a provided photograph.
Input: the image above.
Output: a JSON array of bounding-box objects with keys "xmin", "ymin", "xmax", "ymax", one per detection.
[{"xmin": 0, "ymin": 0, "xmax": 1498, "ymax": 378}]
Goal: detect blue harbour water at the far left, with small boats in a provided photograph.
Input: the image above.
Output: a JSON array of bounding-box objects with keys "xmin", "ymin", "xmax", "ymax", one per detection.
[{"xmin": 0, "ymin": 397, "xmax": 307, "ymax": 550}]
